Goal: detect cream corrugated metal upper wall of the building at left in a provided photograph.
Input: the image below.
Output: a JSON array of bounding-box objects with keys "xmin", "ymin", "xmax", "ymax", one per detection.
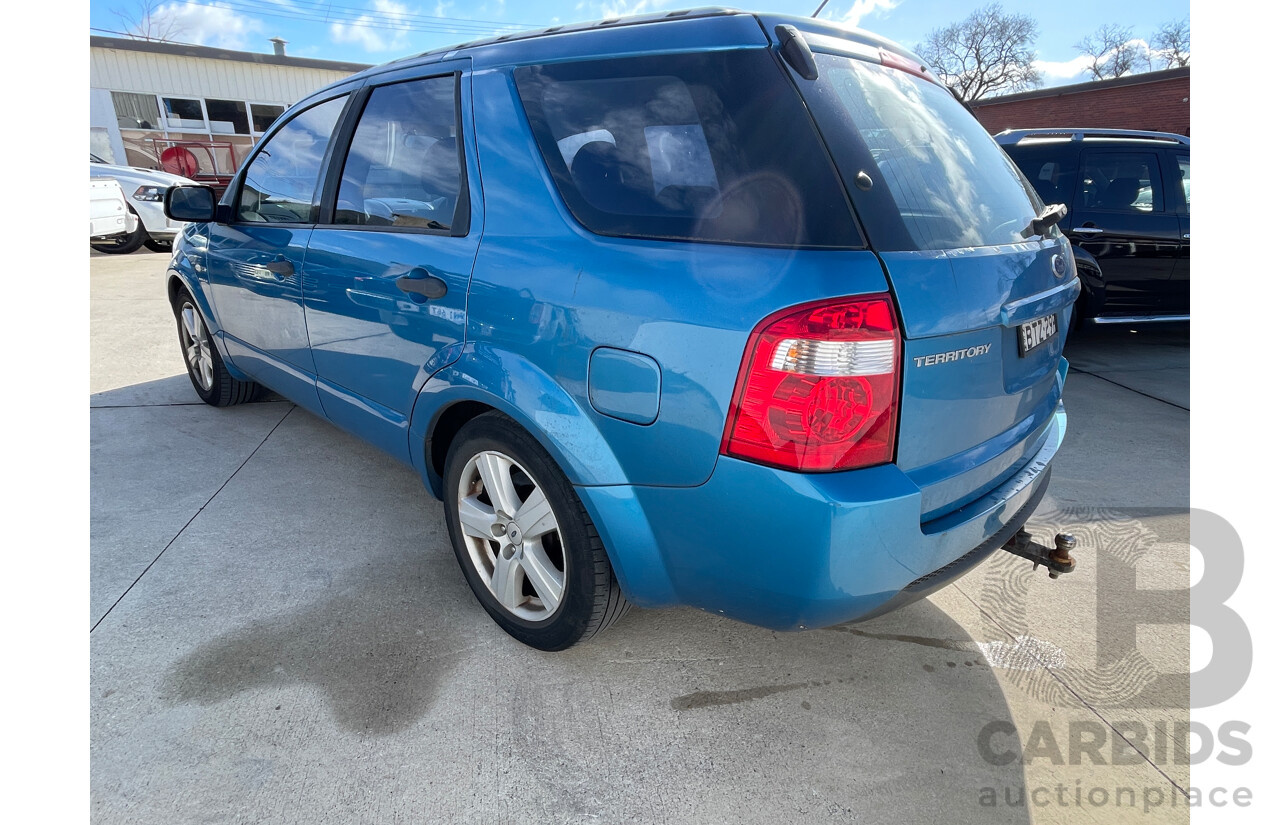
[{"xmin": 90, "ymin": 47, "xmax": 348, "ymax": 104}]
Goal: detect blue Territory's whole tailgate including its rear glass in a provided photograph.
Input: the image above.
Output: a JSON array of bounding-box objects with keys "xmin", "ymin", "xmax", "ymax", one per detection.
[{"xmin": 797, "ymin": 40, "xmax": 1079, "ymax": 521}]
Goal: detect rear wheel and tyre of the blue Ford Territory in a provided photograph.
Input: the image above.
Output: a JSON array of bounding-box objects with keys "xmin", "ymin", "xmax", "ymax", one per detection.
[{"xmin": 444, "ymin": 412, "xmax": 631, "ymax": 651}]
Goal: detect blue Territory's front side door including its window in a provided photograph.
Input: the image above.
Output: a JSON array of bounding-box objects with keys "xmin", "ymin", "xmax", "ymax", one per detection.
[{"xmin": 207, "ymin": 96, "xmax": 347, "ymax": 411}]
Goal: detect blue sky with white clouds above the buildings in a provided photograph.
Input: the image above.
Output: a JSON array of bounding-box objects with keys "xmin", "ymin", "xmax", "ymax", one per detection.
[{"xmin": 90, "ymin": 0, "xmax": 1190, "ymax": 86}]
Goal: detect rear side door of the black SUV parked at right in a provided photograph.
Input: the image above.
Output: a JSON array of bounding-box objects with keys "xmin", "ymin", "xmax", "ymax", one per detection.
[{"xmin": 1068, "ymin": 148, "xmax": 1181, "ymax": 316}]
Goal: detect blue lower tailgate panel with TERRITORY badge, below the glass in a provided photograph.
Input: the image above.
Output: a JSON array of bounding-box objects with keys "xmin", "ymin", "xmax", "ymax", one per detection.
[{"xmin": 881, "ymin": 239, "xmax": 1079, "ymax": 521}]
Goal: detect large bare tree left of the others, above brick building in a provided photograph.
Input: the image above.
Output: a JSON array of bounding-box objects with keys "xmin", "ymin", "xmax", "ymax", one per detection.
[{"xmin": 915, "ymin": 3, "xmax": 1042, "ymax": 102}]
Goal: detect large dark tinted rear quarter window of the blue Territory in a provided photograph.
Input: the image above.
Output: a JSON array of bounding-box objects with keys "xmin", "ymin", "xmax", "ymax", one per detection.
[{"xmin": 516, "ymin": 50, "xmax": 863, "ymax": 247}]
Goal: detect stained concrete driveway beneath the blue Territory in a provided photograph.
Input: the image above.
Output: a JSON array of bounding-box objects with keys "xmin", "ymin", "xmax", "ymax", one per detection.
[{"xmin": 90, "ymin": 253, "xmax": 1189, "ymax": 825}]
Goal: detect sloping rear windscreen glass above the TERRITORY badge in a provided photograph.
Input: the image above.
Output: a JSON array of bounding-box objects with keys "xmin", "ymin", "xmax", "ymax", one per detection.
[{"xmin": 805, "ymin": 54, "xmax": 1036, "ymax": 249}]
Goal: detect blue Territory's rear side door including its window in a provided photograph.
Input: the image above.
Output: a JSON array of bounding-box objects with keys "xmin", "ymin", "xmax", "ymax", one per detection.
[{"xmin": 302, "ymin": 63, "xmax": 480, "ymax": 460}]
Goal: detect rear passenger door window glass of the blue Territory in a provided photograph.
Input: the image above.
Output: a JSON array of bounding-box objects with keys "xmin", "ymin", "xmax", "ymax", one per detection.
[{"xmin": 334, "ymin": 74, "xmax": 462, "ymax": 232}]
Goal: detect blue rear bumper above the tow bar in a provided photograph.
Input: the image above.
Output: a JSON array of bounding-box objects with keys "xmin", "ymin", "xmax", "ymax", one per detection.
[{"xmin": 579, "ymin": 404, "xmax": 1066, "ymax": 631}]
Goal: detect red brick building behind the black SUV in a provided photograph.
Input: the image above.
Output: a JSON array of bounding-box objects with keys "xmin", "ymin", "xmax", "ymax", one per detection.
[{"xmin": 970, "ymin": 67, "xmax": 1192, "ymax": 134}]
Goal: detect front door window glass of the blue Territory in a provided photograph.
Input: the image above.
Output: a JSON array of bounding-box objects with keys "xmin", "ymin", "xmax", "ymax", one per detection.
[{"xmin": 236, "ymin": 97, "xmax": 347, "ymax": 224}]
